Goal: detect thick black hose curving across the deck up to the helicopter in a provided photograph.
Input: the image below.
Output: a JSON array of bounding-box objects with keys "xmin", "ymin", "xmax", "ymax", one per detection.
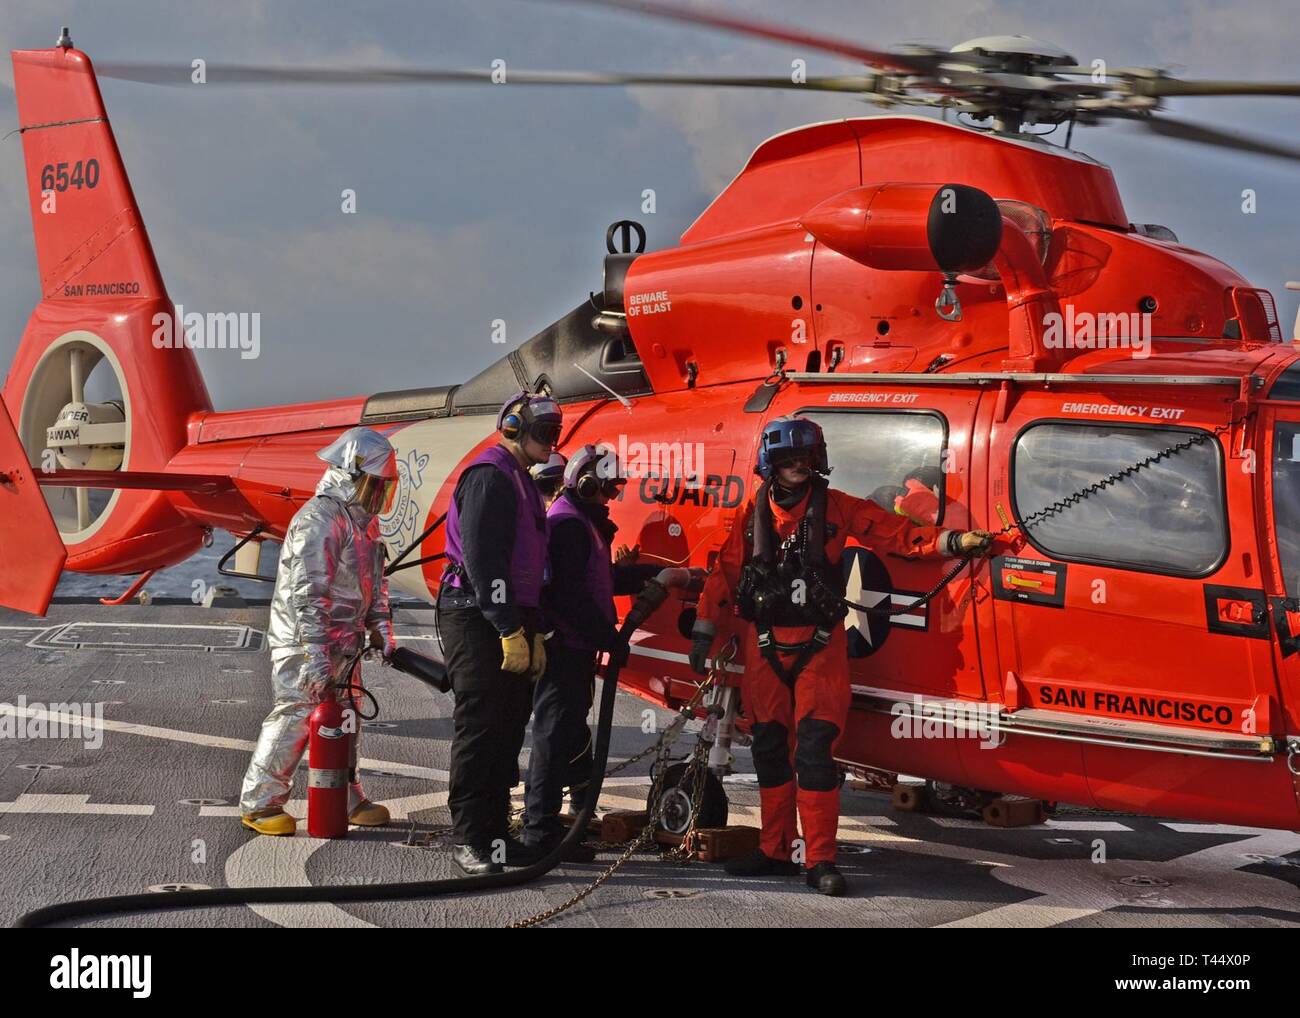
[{"xmin": 13, "ymin": 621, "xmax": 634, "ymax": 930}]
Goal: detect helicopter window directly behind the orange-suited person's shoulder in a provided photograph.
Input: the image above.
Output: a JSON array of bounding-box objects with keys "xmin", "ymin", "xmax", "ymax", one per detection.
[{"xmin": 800, "ymin": 411, "xmax": 948, "ymax": 525}]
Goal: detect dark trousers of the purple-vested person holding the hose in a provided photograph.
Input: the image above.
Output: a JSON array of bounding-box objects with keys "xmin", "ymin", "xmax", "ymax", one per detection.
[{"xmin": 524, "ymin": 640, "xmax": 597, "ymax": 845}]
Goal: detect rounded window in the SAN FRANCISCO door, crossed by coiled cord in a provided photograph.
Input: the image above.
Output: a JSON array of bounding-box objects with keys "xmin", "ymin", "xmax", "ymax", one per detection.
[{"xmin": 1011, "ymin": 424, "xmax": 1227, "ymax": 576}]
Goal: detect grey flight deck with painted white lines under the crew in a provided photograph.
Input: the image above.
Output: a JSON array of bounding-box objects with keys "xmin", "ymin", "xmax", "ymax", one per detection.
[{"xmin": 0, "ymin": 603, "xmax": 1300, "ymax": 927}]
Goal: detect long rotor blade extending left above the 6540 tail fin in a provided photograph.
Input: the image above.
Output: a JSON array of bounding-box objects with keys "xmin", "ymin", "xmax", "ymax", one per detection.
[{"xmin": 96, "ymin": 62, "xmax": 878, "ymax": 94}]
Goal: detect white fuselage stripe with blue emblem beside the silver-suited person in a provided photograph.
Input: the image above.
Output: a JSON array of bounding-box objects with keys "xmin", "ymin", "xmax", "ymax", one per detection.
[{"xmin": 380, "ymin": 413, "xmax": 497, "ymax": 602}]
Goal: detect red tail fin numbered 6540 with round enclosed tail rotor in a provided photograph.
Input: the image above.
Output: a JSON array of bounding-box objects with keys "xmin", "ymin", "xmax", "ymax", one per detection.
[{"xmin": 0, "ymin": 39, "xmax": 212, "ymax": 603}]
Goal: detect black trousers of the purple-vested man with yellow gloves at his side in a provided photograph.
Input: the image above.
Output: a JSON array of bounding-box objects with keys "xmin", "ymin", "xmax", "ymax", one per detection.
[{"xmin": 438, "ymin": 608, "xmax": 533, "ymax": 850}]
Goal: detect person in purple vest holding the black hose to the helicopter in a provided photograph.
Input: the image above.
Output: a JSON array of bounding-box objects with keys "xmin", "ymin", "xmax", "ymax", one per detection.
[{"xmin": 524, "ymin": 446, "xmax": 662, "ymax": 862}]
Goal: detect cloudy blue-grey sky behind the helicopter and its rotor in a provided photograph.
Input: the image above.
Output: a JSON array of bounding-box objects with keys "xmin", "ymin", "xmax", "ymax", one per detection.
[{"xmin": 0, "ymin": 0, "xmax": 1300, "ymax": 408}]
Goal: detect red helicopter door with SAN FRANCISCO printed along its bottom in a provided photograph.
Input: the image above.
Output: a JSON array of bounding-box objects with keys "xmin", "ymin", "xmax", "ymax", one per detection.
[{"xmin": 982, "ymin": 387, "xmax": 1278, "ymax": 815}]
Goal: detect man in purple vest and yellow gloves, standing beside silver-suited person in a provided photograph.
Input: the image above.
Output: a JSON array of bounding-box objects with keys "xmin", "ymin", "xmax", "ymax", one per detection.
[{"xmin": 437, "ymin": 391, "xmax": 563, "ymax": 875}]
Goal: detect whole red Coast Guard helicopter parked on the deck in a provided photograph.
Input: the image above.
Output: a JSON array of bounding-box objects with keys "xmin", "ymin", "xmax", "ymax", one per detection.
[{"xmin": 0, "ymin": 3, "xmax": 1300, "ymax": 828}]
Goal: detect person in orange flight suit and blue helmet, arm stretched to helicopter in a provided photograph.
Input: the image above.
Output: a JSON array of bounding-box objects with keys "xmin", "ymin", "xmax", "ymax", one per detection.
[{"xmin": 690, "ymin": 417, "xmax": 992, "ymax": 894}]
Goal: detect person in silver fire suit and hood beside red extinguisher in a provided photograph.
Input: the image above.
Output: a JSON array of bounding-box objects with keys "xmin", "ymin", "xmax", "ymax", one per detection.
[{"xmin": 239, "ymin": 428, "xmax": 398, "ymax": 835}]
